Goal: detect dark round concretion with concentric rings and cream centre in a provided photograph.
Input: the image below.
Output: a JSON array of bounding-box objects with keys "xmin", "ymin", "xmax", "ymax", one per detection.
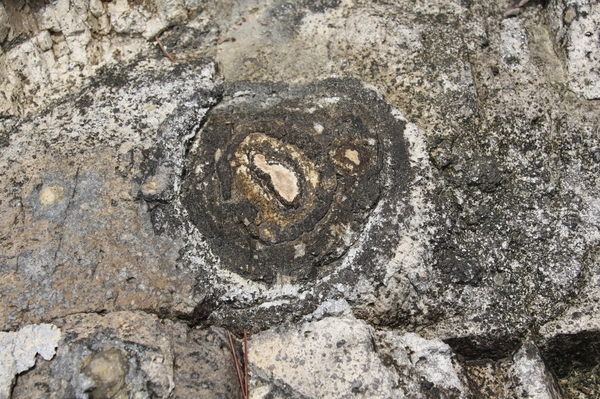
[{"xmin": 181, "ymin": 79, "xmax": 409, "ymax": 283}]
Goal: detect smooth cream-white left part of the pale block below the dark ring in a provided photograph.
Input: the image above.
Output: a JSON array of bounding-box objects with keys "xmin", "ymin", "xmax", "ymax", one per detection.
[{"xmin": 249, "ymin": 318, "xmax": 401, "ymax": 398}]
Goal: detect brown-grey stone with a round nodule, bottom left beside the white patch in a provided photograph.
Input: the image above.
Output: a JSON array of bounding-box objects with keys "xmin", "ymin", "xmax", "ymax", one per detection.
[{"xmin": 12, "ymin": 312, "xmax": 238, "ymax": 398}]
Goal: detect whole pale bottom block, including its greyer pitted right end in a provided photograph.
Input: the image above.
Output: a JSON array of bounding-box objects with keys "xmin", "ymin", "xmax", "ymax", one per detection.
[{"xmin": 250, "ymin": 318, "xmax": 465, "ymax": 398}]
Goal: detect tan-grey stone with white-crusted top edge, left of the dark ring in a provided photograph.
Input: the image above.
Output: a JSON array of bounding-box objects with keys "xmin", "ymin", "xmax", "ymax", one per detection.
[{"xmin": 0, "ymin": 57, "xmax": 220, "ymax": 329}]
